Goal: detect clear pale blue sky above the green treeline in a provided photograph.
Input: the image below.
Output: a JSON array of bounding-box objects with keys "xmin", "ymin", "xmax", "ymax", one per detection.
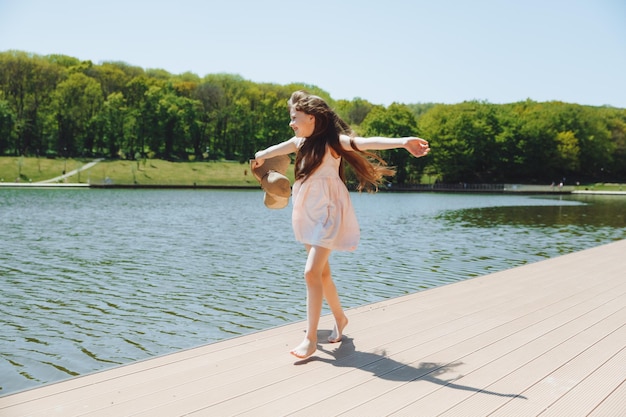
[{"xmin": 0, "ymin": 0, "xmax": 626, "ymax": 108}]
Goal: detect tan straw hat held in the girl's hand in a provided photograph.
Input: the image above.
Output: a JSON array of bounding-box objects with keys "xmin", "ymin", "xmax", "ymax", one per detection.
[{"xmin": 250, "ymin": 155, "xmax": 291, "ymax": 209}]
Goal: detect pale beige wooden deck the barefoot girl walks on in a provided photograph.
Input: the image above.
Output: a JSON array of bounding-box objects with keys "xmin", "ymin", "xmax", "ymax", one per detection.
[{"xmin": 0, "ymin": 240, "xmax": 626, "ymax": 417}]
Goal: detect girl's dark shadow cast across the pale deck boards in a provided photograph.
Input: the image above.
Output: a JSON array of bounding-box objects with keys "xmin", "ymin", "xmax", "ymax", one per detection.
[{"xmin": 297, "ymin": 335, "xmax": 527, "ymax": 399}]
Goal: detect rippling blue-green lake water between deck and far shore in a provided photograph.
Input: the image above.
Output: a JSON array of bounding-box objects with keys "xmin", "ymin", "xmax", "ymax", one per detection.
[{"xmin": 0, "ymin": 189, "xmax": 626, "ymax": 395}]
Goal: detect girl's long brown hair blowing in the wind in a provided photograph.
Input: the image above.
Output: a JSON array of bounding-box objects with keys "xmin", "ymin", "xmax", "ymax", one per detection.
[{"xmin": 289, "ymin": 91, "xmax": 395, "ymax": 191}]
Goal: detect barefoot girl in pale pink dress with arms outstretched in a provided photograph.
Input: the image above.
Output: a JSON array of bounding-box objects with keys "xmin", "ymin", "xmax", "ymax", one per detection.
[{"xmin": 254, "ymin": 91, "xmax": 430, "ymax": 359}]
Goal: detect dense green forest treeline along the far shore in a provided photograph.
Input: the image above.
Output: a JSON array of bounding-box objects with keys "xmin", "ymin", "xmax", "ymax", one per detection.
[{"xmin": 0, "ymin": 51, "xmax": 626, "ymax": 184}]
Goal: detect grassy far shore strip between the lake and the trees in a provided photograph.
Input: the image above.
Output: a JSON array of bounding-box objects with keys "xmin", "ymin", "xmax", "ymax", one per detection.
[{"xmin": 0, "ymin": 157, "xmax": 626, "ymax": 195}]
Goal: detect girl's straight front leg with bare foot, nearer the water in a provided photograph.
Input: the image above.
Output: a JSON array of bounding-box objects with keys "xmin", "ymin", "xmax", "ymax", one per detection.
[{"xmin": 291, "ymin": 245, "xmax": 336, "ymax": 359}]
